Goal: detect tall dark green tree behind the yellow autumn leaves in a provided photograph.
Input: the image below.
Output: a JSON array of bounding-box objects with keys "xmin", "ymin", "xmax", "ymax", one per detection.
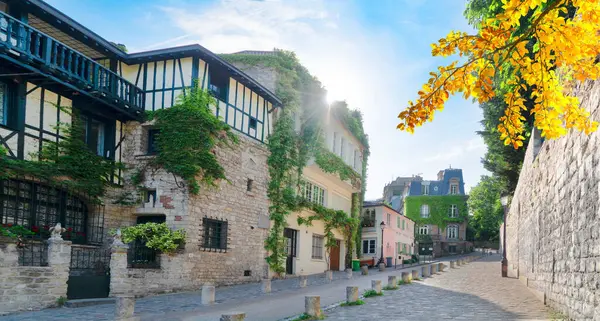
[{"xmin": 464, "ymin": 0, "xmax": 533, "ymax": 192}]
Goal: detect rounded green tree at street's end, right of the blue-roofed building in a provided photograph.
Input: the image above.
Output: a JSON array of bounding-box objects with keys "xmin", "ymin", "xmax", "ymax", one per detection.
[{"xmin": 468, "ymin": 175, "xmax": 504, "ymax": 242}]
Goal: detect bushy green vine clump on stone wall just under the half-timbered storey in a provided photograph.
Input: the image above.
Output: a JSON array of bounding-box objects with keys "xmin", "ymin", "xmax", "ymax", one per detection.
[{"xmin": 144, "ymin": 84, "xmax": 237, "ymax": 194}]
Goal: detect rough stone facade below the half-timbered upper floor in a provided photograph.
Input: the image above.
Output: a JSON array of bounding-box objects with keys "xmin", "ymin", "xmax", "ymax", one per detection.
[{"xmin": 104, "ymin": 122, "xmax": 269, "ymax": 296}]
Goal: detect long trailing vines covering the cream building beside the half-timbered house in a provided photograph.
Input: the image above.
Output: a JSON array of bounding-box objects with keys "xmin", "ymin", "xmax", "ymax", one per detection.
[{"xmin": 221, "ymin": 50, "xmax": 368, "ymax": 273}]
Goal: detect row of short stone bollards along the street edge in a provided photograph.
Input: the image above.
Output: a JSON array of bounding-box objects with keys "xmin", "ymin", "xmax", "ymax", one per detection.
[{"xmin": 115, "ymin": 256, "xmax": 477, "ymax": 321}]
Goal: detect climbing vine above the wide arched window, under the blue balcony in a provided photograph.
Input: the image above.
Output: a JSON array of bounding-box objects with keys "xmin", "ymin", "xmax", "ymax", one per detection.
[{"xmin": 0, "ymin": 109, "xmax": 123, "ymax": 202}]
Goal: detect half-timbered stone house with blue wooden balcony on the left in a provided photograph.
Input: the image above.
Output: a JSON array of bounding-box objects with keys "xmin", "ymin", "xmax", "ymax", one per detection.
[{"xmin": 0, "ymin": 0, "xmax": 281, "ymax": 311}]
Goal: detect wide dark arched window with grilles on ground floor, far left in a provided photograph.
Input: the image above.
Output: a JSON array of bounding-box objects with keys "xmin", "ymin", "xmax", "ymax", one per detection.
[{"xmin": 0, "ymin": 179, "xmax": 88, "ymax": 243}]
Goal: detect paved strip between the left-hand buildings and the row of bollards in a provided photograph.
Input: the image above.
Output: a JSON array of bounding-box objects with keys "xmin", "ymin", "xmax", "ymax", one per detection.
[{"xmin": 0, "ymin": 256, "xmax": 440, "ymax": 321}]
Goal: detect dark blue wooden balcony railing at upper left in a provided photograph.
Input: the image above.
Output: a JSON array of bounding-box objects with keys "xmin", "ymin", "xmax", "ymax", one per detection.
[{"xmin": 0, "ymin": 12, "xmax": 144, "ymax": 110}]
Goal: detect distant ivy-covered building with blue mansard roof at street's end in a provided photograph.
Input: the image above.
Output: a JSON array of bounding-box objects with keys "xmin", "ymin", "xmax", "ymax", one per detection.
[{"xmin": 403, "ymin": 168, "xmax": 472, "ymax": 257}]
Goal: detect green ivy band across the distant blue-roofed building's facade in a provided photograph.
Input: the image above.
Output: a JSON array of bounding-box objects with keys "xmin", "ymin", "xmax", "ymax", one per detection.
[{"xmin": 404, "ymin": 195, "xmax": 468, "ymax": 229}]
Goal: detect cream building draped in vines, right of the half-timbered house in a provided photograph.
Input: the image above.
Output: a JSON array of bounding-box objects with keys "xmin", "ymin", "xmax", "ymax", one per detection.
[{"xmin": 225, "ymin": 50, "xmax": 366, "ymax": 275}]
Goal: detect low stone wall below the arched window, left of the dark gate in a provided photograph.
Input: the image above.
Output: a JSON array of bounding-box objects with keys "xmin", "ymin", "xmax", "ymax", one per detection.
[{"xmin": 0, "ymin": 240, "xmax": 71, "ymax": 315}]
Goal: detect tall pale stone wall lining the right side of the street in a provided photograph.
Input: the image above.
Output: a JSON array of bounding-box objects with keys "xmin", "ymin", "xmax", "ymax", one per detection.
[{"xmin": 506, "ymin": 82, "xmax": 600, "ymax": 320}]
